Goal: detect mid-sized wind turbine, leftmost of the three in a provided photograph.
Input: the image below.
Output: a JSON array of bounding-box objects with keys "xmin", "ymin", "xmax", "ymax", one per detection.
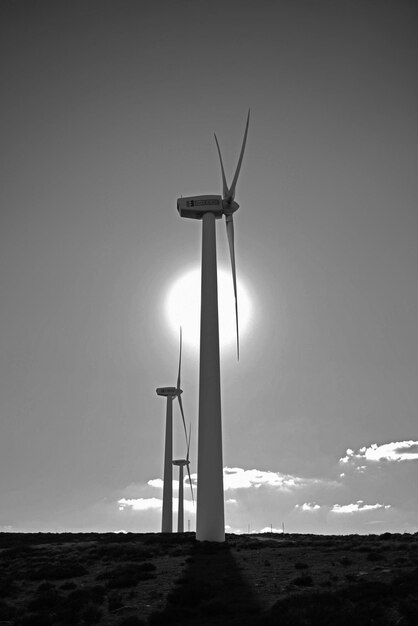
[{"xmin": 156, "ymin": 328, "xmax": 187, "ymax": 533}]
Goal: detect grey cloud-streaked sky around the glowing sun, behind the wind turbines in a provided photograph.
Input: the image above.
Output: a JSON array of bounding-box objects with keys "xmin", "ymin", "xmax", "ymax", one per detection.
[{"xmin": 0, "ymin": 0, "xmax": 418, "ymax": 534}]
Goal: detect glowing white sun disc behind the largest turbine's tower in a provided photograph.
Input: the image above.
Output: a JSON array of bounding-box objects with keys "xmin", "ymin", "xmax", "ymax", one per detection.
[{"xmin": 165, "ymin": 267, "xmax": 252, "ymax": 348}]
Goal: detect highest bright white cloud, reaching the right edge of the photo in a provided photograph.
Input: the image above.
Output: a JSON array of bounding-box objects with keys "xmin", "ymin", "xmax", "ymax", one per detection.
[{"xmin": 340, "ymin": 439, "xmax": 418, "ymax": 470}]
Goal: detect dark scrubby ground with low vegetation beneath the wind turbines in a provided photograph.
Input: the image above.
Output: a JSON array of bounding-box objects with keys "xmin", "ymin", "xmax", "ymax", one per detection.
[{"xmin": 0, "ymin": 533, "xmax": 418, "ymax": 626}]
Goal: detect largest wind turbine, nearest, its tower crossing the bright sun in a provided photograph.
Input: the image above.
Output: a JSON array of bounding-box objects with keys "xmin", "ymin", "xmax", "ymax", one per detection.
[{"xmin": 177, "ymin": 111, "xmax": 250, "ymax": 541}]
